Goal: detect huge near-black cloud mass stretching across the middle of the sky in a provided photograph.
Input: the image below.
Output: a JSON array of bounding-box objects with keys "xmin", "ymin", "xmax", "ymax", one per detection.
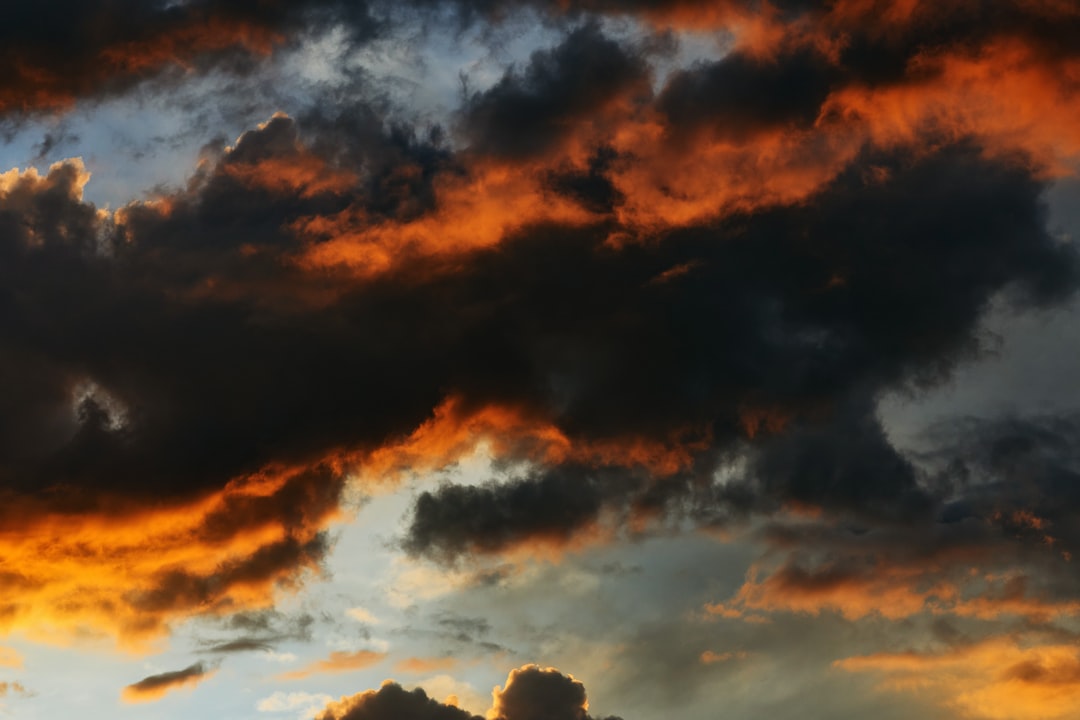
[{"xmin": 0, "ymin": 90, "xmax": 1077, "ymax": 561}]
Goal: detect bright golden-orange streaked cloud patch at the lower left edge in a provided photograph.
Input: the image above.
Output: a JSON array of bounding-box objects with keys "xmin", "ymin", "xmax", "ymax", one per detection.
[{"xmin": 0, "ymin": 467, "xmax": 341, "ymax": 652}]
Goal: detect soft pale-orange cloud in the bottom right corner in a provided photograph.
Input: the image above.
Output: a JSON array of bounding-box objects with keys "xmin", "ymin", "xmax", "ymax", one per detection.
[{"xmin": 834, "ymin": 638, "xmax": 1080, "ymax": 720}]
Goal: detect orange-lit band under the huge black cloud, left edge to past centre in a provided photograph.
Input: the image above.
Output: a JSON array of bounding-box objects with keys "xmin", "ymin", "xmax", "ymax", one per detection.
[{"xmin": 0, "ymin": 390, "xmax": 692, "ymax": 660}]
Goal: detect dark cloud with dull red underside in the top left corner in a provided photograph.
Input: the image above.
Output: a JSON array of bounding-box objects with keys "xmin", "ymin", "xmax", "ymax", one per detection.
[{"xmin": 0, "ymin": 0, "xmax": 376, "ymax": 117}]
